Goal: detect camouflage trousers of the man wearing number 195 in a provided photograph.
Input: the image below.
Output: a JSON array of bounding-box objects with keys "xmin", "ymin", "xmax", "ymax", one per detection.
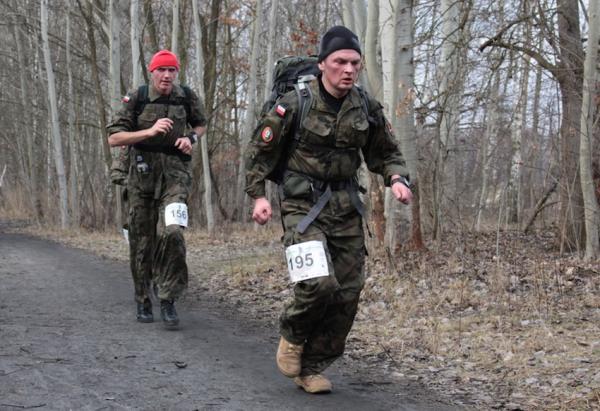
[{"xmin": 280, "ymin": 193, "xmax": 365, "ymax": 375}]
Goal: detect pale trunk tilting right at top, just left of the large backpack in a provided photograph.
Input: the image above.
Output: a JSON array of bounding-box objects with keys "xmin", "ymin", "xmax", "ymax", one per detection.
[{"xmin": 236, "ymin": 0, "xmax": 262, "ymax": 221}]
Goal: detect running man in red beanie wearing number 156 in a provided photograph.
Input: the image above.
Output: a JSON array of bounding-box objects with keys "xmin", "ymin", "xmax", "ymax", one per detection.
[{"xmin": 107, "ymin": 50, "xmax": 206, "ymax": 328}]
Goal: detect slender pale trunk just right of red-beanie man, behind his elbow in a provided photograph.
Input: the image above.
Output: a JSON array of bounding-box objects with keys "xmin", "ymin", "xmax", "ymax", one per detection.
[{"xmin": 192, "ymin": 0, "xmax": 215, "ymax": 235}]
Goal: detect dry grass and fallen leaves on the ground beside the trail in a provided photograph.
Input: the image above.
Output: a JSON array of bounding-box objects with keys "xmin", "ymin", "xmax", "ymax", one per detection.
[{"xmin": 4, "ymin": 219, "xmax": 600, "ymax": 410}]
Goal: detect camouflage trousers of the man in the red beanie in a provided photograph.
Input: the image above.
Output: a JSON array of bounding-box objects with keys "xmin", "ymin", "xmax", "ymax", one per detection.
[{"xmin": 127, "ymin": 153, "xmax": 191, "ymax": 302}]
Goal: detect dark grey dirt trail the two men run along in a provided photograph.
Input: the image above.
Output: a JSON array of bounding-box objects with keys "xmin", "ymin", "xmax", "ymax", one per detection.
[{"xmin": 0, "ymin": 233, "xmax": 459, "ymax": 410}]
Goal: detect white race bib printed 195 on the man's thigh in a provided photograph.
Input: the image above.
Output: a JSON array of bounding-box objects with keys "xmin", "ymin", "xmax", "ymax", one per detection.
[{"xmin": 285, "ymin": 241, "xmax": 329, "ymax": 283}]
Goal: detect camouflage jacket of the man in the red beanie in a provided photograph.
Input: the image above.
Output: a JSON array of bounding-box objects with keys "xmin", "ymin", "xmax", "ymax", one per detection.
[{"xmin": 107, "ymin": 85, "xmax": 206, "ymax": 153}]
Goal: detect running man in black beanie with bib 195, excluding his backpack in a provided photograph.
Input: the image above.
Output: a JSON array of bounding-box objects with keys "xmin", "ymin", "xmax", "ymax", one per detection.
[{"xmin": 246, "ymin": 26, "xmax": 412, "ymax": 393}]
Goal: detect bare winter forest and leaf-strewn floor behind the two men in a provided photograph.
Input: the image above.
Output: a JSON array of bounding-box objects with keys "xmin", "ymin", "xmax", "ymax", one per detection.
[{"xmin": 0, "ymin": 0, "xmax": 600, "ymax": 409}]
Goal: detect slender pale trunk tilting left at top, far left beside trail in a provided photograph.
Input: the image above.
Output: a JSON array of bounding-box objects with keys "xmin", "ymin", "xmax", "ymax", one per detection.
[{"xmin": 40, "ymin": 0, "xmax": 69, "ymax": 230}]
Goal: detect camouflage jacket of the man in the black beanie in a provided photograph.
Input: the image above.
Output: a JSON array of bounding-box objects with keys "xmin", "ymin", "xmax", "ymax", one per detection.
[{"xmin": 246, "ymin": 80, "xmax": 408, "ymax": 198}]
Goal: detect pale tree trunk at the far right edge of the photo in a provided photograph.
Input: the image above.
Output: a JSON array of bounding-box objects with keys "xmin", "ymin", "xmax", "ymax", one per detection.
[{"xmin": 579, "ymin": 0, "xmax": 600, "ymax": 261}]
